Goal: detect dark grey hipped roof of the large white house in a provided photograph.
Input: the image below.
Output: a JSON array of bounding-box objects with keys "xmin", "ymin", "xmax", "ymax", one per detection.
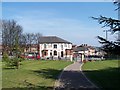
[{"xmin": 39, "ymin": 36, "xmax": 72, "ymax": 44}]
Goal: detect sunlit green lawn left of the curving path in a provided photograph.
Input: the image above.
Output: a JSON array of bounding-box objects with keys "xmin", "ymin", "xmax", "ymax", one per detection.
[{"xmin": 2, "ymin": 60, "xmax": 72, "ymax": 90}]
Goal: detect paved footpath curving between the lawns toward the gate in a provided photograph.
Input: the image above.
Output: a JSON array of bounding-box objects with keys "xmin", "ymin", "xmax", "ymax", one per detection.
[{"xmin": 54, "ymin": 62, "xmax": 99, "ymax": 90}]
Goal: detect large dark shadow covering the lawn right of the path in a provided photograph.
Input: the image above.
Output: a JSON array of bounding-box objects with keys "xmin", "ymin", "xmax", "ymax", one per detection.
[{"xmin": 83, "ymin": 67, "xmax": 120, "ymax": 90}]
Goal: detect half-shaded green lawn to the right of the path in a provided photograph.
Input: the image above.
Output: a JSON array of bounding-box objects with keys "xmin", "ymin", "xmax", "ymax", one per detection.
[{"xmin": 82, "ymin": 60, "xmax": 120, "ymax": 90}]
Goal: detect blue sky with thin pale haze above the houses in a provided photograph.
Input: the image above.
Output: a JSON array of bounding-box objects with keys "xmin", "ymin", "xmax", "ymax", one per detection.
[{"xmin": 2, "ymin": 2, "xmax": 118, "ymax": 46}]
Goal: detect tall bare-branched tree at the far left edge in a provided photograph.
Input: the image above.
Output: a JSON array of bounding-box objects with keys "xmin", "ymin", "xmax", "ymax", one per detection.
[{"xmin": 2, "ymin": 20, "xmax": 22, "ymax": 54}]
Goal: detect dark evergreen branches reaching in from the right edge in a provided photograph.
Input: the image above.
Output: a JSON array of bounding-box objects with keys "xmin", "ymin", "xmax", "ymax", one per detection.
[{"xmin": 92, "ymin": 1, "xmax": 120, "ymax": 56}]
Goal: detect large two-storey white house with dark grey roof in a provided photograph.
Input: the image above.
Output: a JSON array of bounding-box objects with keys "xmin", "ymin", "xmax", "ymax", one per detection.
[{"xmin": 39, "ymin": 36, "xmax": 72, "ymax": 60}]
